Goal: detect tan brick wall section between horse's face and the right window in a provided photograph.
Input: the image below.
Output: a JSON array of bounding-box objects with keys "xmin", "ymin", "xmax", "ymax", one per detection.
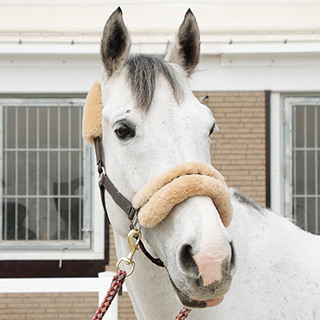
[{"xmin": 195, "ymin": 92, "xmax": 266, "ymax": 206}]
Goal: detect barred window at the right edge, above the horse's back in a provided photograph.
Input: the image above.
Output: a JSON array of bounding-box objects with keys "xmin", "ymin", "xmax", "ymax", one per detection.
[{"xmin": 283, "ymin": 97, "xmax": 320, "ymax": 234}]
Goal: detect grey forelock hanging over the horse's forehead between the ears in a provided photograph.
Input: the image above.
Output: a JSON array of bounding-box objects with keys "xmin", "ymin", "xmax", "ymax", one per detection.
[{"xmin": 126, "ymin": 54, "xmax": 182, "ymax": 112}]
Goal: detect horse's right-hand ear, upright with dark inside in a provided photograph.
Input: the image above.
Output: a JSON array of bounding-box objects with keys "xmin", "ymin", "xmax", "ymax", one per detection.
[{"xmin": 165, "ymin": 9, "xmax": 200, "ymax": 75}]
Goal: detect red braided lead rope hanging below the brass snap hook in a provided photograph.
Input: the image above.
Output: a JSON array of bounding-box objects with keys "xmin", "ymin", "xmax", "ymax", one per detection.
[{"xmin": 92, "ymin": 270, "xmax": 192, "ymax": 320}]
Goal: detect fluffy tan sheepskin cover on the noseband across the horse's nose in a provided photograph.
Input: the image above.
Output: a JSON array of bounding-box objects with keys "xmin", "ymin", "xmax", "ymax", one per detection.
[{"xmin": 132, "ymin": 162, "xmax": 232, "ymax": 228}]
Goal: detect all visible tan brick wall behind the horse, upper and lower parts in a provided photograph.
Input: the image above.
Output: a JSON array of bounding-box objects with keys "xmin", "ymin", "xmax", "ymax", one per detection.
[{"xmin": 0, "ymin": 92, "xmax": 266, "ymax": 320}]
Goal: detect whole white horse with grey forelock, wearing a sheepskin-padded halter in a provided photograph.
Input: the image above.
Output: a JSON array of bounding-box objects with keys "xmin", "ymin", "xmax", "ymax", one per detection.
[{"xmin": 93, "ymin": 9, "xmax": 320, "ymax": 320}]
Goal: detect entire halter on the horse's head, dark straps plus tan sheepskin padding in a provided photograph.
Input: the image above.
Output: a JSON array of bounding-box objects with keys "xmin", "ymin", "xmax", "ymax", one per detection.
[{"xmin": 83, "ymin": 80, "xmax": 232, "ymax": 267}]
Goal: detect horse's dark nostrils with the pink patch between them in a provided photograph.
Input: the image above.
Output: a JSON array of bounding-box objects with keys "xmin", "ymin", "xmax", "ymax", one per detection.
[{"xmin": 178, "ymin": 242, "xmax": 235, "ymax": 286}]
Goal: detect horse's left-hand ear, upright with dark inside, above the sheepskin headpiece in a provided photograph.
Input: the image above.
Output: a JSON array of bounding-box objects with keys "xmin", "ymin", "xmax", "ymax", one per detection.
[{"xmin": 100, "ymin": 7, "xmax": 131, "ymax": 77}]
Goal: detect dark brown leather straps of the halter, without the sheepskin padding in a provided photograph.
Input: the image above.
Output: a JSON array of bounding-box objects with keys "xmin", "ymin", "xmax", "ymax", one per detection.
[{"xmin": 94, "ymin": 137, "xmax": 164, "ymax": 267}]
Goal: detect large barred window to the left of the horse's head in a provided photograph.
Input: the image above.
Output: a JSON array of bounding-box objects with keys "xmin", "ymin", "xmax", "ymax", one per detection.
[{"xmin": 0, "ymin": 98, "xmax": 104, "ymax": 259}]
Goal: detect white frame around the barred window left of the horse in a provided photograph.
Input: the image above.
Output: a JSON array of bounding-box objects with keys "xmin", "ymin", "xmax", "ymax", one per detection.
[{"xmin": 0, "ymin": 98, "xmax": 105, "ymax": 261}]
